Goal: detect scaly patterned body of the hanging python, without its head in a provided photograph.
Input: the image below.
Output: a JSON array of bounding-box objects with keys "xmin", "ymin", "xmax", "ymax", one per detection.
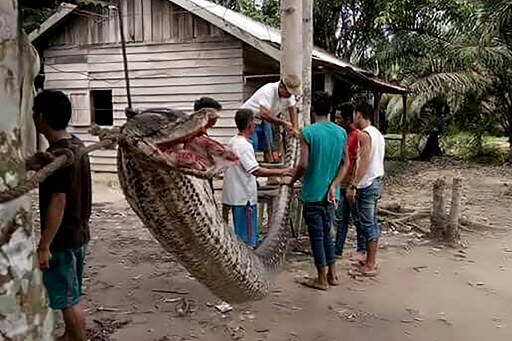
[{"xmin": 117, "ymin": 109, "xmax": 299, "ymax": 303}]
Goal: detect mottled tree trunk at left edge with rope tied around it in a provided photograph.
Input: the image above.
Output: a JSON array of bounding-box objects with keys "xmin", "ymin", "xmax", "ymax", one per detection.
[{"xmin": 0, "ymin": 0, "xmax": 53, "ymax": 340}]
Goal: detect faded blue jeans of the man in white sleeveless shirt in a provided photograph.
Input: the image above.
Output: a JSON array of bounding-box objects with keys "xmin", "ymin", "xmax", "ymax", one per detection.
[{"xmin": 356, "ymin": 178, "xmax": 382, "ymax": 242}]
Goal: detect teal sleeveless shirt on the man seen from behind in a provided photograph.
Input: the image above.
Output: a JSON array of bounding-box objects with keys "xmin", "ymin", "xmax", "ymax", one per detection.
[{"xmin": 301, "ymin": 122, "xmax": 347, "ymax": 202}]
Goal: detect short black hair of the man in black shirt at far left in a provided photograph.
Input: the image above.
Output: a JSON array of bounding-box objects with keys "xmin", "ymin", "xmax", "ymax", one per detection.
[{"xmin": 33, "ymin": 90, "xmax": 71, "ymax": 130}]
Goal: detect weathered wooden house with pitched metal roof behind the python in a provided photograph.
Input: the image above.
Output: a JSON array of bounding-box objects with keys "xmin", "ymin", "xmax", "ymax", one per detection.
[{"xmin": 29, "ymin": 0, "xmax": 405, "ymax": 172}]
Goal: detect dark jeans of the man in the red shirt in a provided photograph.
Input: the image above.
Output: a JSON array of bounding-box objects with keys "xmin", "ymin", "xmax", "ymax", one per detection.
[{"xmin": 334, "ymin": 188, "xmax": 366, "ymax": 256}]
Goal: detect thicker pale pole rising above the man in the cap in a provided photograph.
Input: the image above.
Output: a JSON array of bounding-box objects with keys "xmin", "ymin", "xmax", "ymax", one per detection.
[{"xmin": 281, "ymin": 0, "xmax": 303, "ymax": 125}]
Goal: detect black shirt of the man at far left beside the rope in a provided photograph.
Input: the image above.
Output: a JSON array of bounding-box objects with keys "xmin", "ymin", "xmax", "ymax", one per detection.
[{"xmin": 39, "ymin": 136, "xmax": 92, "ymax": 251}]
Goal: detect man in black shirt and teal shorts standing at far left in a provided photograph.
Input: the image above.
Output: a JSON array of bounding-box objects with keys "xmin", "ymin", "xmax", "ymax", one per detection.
[{"xmin": 33, "ymin": 90, "xmax": 91, "ymax": 341}]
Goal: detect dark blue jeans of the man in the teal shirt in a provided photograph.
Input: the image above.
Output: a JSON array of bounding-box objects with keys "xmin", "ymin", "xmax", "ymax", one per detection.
[{"xmin": 303, "ymin": 202, "xmax": 335, "ymax": 266}]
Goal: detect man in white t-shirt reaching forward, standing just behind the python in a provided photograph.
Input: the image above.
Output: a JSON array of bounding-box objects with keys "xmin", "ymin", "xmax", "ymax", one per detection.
[{"xmin": 222, "ymin": 109, "xmax": 293, "ymax": 248}]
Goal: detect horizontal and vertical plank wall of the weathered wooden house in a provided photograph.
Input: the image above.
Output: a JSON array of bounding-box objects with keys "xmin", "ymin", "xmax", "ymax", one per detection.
[{"xmin": 44, "ymin": 0, "xmax": 244, "ymax": 172}]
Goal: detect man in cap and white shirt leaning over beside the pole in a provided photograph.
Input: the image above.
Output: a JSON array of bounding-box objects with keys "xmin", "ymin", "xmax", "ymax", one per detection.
[{"xmin": 242, "ymin": 75, "xmax": 300, "ymax": 162}]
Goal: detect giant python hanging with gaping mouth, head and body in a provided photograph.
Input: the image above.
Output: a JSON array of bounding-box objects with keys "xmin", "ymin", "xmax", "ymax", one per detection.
[{"xmin": 117, "ymin": 109, "xmax": 299, "ymax": 303}]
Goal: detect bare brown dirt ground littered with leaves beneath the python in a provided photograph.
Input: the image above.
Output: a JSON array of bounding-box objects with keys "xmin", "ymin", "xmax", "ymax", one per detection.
[{"xmin": 37, "ymin": 162, "xmax": 512, "ymax": 341}]
